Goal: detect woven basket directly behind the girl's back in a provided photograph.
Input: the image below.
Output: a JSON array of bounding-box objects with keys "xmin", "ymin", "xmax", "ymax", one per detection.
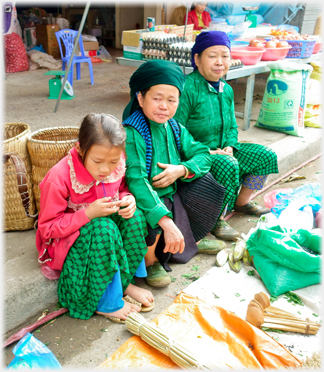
[{"xmin": 27, "ymin": 127, "xmax": 79, "ymax": 211}]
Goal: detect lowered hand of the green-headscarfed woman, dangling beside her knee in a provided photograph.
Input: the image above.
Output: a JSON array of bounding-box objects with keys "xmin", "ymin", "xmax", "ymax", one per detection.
[{"xmin": 159, "ymin": 217, "xmax": 185, "ymax": 254}]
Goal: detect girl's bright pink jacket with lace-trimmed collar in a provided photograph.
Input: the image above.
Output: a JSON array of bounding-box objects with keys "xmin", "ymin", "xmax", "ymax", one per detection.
[{"xmin": 36, "ymin": 148, "xmax": 130, "ymax": 270}]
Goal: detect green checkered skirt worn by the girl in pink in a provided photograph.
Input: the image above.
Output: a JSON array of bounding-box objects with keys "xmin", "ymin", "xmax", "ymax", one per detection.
[{"xmin": 58, "ymin": 210, "xmax": 147, "ymax": 319}]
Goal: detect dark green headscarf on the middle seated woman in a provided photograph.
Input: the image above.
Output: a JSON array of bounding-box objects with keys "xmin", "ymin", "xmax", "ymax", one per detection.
[{"xmin": 123, "ymin": 59, "xmax": 185, "ymax": 120}]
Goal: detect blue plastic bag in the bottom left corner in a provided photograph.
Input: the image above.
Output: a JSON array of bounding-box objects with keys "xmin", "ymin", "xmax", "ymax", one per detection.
[{"xmin": 6, "ymin": 333, "xmax": 63, "ymax": 370}]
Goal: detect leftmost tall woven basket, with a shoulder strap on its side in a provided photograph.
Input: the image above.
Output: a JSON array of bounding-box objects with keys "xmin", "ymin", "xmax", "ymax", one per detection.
[{"xmin": 2, "ymin": 123, "xmax": 36, "ymax": 231}]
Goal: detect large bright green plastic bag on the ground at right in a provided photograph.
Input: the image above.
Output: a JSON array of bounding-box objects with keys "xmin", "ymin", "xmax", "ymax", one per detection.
[{"xmin": 247, "ymin": 225, "xmax": 322, "ymax": 296}]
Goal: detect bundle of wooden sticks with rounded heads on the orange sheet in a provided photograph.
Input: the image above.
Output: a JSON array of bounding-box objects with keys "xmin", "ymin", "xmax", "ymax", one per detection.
[{"xmin": 246, "ymin": 292, "xmax": 320, "ymax": 335}]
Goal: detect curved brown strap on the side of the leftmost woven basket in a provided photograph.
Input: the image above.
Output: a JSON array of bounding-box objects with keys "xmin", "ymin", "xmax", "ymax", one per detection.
[{"xmin": 3, "ymin": 152, "xmax": 38, "ymax": 218}]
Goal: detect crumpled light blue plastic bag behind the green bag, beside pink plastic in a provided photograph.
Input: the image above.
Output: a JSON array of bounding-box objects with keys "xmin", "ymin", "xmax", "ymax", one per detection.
[{"xmin": 271, "ymin": 183, "xmax": 322, "ymax": 217}]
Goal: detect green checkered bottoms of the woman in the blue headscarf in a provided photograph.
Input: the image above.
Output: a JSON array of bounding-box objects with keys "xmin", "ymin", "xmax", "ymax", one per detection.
[{"xmin": 210, "ymin": 143, "xmax": 279, "ymax": 211}]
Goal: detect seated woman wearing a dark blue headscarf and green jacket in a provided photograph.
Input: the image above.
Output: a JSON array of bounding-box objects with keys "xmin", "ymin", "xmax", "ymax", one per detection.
[{"xmin": 175, "ymin": 31, "xmax": 278, "ymax": 240}]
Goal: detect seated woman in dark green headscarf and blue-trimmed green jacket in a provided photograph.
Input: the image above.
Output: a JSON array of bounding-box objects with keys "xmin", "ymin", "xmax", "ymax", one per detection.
[{"xmin": 123, "ymin": 60, "xmax": 226, "ymax": 287}]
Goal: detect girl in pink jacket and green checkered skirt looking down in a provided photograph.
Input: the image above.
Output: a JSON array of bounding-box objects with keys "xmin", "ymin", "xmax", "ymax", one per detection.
[{"xmin": 36, "ymin": 114, "xmax": 154, "ymax": 323}]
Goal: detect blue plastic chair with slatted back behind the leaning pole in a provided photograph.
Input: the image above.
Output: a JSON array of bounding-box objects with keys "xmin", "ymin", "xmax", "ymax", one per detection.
[{"xmin": 55, "ymin": 29, "xmax": 94, "ymax": 86}]
